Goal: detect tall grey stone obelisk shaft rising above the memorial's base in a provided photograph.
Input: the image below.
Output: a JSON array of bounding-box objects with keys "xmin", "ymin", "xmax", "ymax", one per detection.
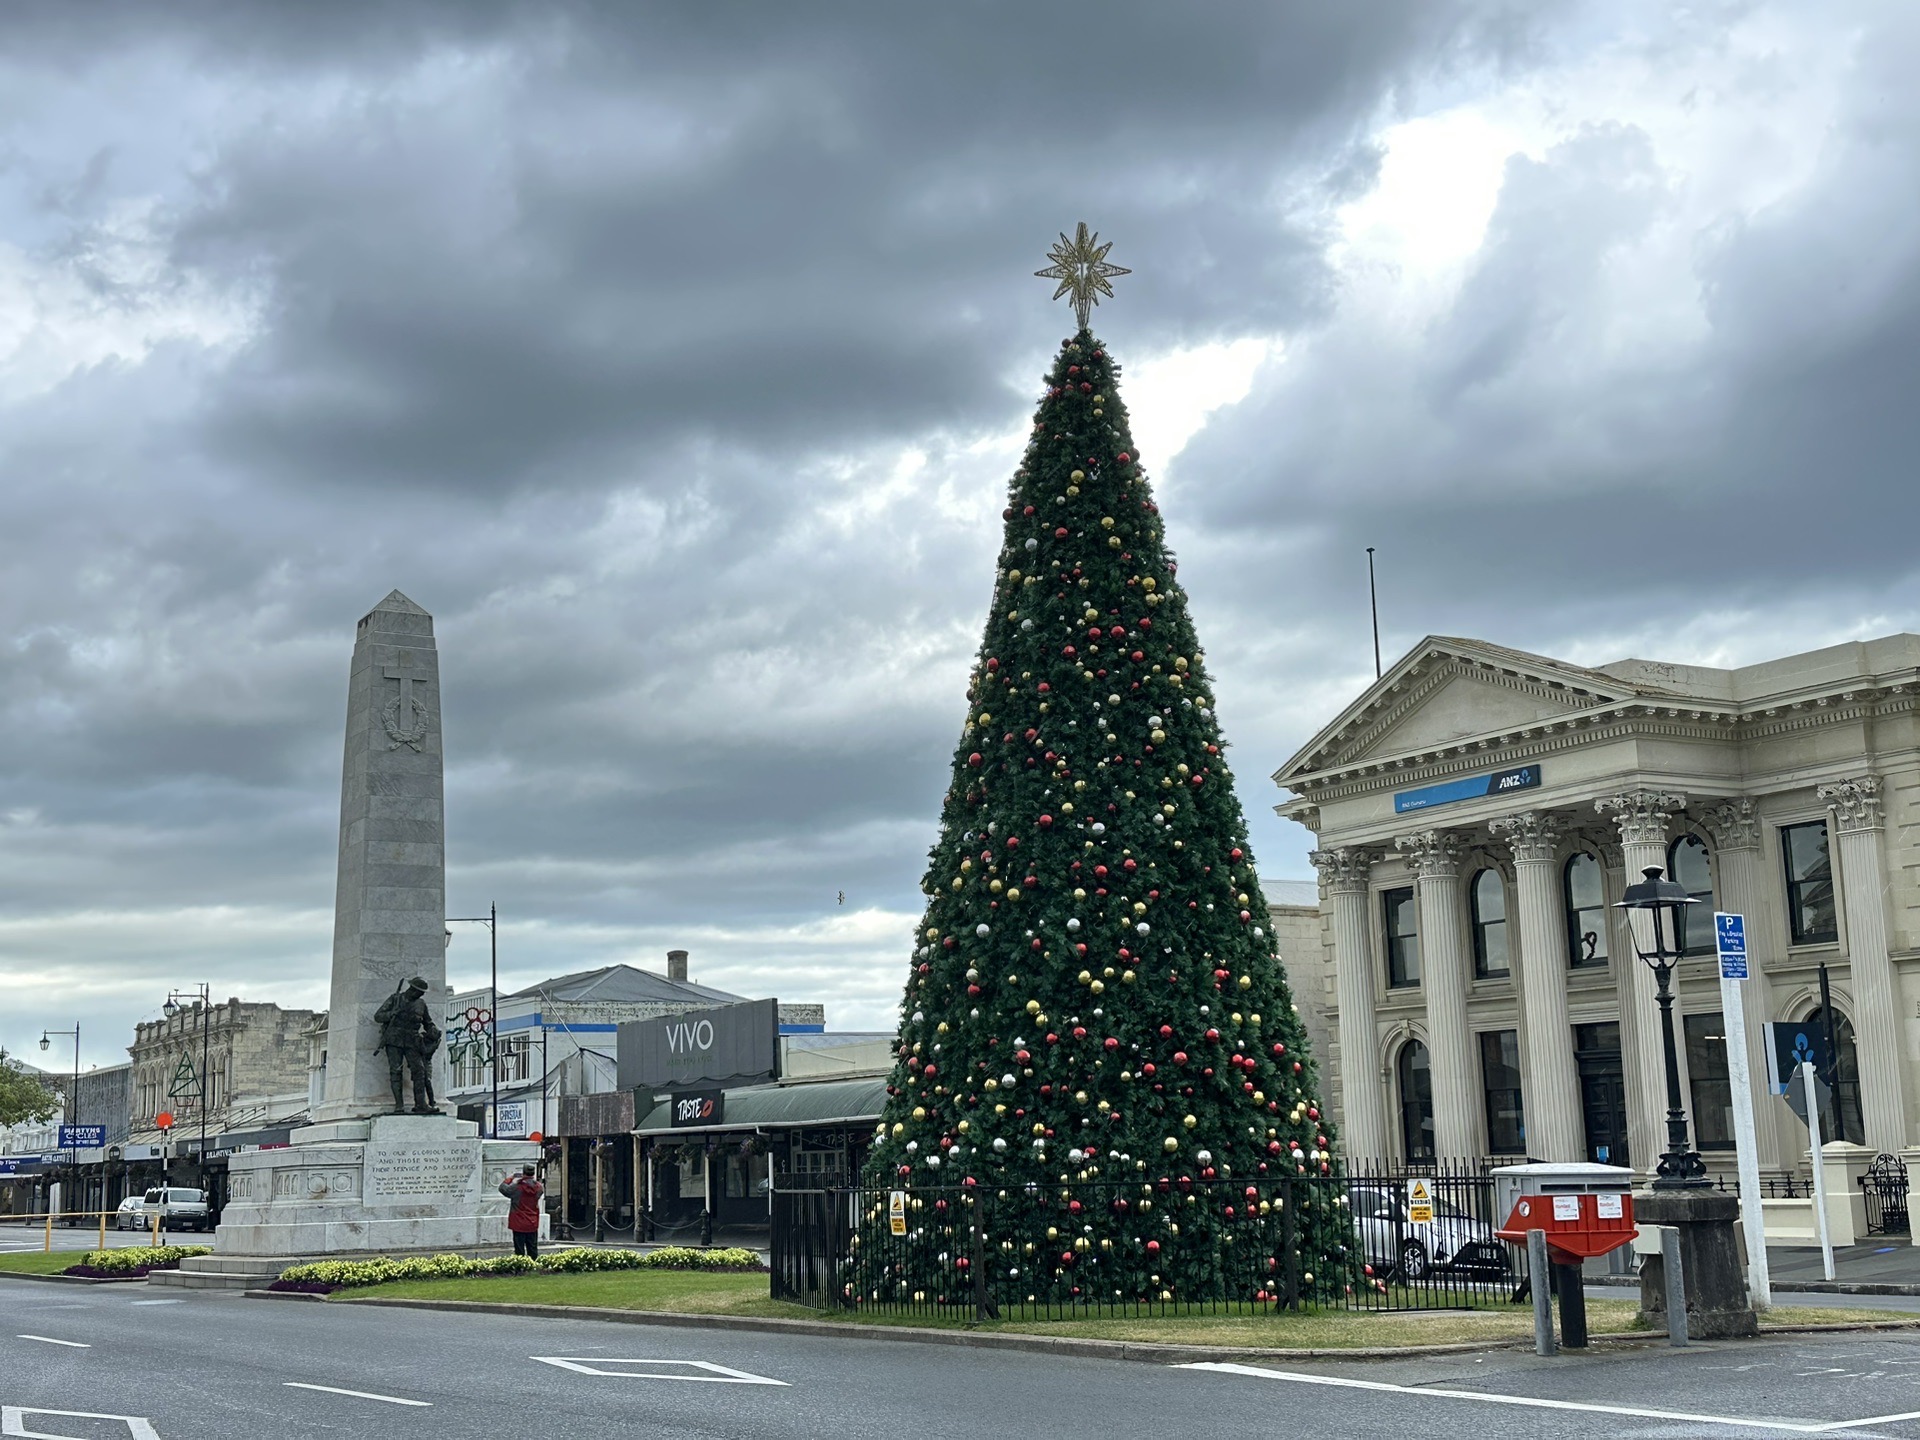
[{"xmin": 313, "ymin": 589, "xmax": 447, "ymax": 1123}]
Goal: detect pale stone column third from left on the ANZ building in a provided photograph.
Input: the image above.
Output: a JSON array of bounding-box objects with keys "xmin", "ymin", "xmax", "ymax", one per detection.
[{"xmin": 1488, "ymin": 810, "xmax": 1586, "ymax": 1160}]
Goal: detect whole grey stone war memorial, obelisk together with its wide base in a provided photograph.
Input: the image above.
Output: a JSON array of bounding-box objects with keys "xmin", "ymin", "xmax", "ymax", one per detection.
[{"xmin": 213, "ymin": 589, "xmax": 540, "ymax": 1260}]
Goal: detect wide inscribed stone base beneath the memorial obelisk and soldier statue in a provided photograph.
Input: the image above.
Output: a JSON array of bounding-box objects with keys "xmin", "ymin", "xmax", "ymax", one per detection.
[{"xmin": 213, "ymin": 1116, "xmax": 540, "ymax": 1258}]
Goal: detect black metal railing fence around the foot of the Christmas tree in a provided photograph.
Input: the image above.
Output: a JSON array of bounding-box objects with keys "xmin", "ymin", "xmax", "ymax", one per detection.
[{"xmin": 772, "ymin": 1167, "xmax": 1526, "ymax": 1319}]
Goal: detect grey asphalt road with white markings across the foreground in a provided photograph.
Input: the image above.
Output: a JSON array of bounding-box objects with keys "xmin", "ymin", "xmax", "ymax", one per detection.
[{"xmin": 0, "ymin": 1279, "xmax": 1920, "ymax": 1440}]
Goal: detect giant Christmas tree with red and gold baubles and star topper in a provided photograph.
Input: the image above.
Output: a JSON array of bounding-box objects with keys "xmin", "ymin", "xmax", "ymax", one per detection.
[{"xmin": 849, "ymin": 225, "xmax": 1354, "ymax": 1302}]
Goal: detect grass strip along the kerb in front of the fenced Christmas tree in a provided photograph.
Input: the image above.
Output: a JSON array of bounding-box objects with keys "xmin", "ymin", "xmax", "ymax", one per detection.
[{"xmin": 334, "ymin": 1271, "xmax": 1903, "ymax": 1350}]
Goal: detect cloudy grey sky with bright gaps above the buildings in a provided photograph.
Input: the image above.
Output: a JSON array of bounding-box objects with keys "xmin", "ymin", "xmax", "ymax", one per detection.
[{"xmin": 0, "ymin": 0, "xmax": 1920, "ymax": 1064}]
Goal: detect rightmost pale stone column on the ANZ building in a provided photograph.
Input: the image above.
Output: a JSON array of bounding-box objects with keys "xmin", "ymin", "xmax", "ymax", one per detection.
[{"xmin": 1814, "ymin": 776, "xmax": 1912, "ymax": 1154}]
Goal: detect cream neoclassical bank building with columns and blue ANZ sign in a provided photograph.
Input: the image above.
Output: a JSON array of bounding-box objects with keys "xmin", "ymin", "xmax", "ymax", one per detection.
[{"xmin": 1273, "ymin": 636, "xmax": 1920, "ymax": 1171}]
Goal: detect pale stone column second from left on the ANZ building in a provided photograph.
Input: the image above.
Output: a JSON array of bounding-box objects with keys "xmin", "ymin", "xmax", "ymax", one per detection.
[{"xmin": 1394, "ymin": 829, "xmax": 1486, "ymax": 1160}]
